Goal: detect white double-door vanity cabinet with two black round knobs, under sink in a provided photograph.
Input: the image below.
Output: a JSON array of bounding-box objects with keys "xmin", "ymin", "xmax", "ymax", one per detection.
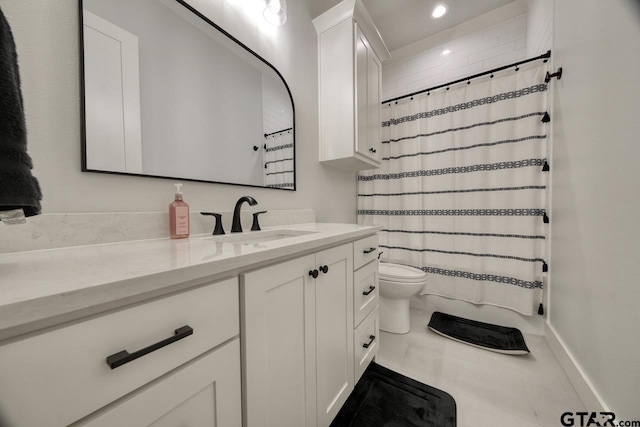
[{"xmin": 241, "ymin": 243, "xmax": 354, "ymax": 427}]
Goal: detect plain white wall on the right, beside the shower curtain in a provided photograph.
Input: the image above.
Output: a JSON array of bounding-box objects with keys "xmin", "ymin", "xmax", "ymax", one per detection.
[{"xmin": 549, "ymin": 0, "xmax": 640, "ymax": 420}]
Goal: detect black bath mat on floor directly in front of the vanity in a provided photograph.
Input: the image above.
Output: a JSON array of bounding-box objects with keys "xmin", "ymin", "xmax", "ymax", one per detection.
[{"xmin": 331, "ymin": 362, "xmax": 456, "ymax": 427}]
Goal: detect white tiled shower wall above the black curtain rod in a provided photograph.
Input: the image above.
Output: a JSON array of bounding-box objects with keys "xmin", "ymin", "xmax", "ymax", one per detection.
[{"xmin": 382, "ymin": 1, "xmax": 527, "ymax": 100}]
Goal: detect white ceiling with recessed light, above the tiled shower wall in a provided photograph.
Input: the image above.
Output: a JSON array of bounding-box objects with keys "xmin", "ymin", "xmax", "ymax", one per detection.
[{"xmin": 308, "ymin": 0, "xmax": 514, "ymax": 51}]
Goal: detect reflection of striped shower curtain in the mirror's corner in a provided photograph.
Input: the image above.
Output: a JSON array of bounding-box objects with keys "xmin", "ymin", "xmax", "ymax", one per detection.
[{"xmin": 264, "ymin": 129, "xmax": 294, "ymax": 189}]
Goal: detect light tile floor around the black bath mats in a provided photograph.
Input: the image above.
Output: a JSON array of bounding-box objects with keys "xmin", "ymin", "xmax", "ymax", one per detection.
[{"xmin": 376, "ymin": 309, "xmax": 585, "ymax": 427}]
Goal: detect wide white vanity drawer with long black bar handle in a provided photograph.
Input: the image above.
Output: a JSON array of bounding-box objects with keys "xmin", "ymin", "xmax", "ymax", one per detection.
[{"xmin": 0, "ymin": 277, "xmax": 239, "ymax": 427}]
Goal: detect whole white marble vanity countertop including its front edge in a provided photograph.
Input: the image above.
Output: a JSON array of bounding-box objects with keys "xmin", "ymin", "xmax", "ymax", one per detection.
[{"xmin": 0, "ymin": 223, "xmax": 381, "ymax": 339}]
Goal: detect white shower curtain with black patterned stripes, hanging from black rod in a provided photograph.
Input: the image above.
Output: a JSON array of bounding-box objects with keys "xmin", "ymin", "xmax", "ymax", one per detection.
[{"xmin": 358, "ymin": 64, "xmax": 548, "ymax": 315}]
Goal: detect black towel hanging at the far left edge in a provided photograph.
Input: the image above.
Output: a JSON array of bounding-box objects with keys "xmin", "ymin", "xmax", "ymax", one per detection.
[{"xmin": 0, "ymin": 9, "xmax": 42, "ymax": 216}]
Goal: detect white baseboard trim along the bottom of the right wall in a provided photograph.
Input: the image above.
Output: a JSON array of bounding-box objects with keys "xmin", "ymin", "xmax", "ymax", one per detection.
[{"xmin": 544, "ymin": 322, "xmax": 610, "ymax": 412}]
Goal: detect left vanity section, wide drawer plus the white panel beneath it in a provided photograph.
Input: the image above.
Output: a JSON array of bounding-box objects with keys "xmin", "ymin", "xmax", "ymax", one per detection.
[{"xmin": 0, "ymin": 277, "xmax": 242, "ymax": 427}]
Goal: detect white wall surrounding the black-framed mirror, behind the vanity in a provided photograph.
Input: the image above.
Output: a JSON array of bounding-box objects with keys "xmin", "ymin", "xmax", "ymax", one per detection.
[{"xmin": 0, "ymin": 0, "xmax": 356, "ymax": 222}]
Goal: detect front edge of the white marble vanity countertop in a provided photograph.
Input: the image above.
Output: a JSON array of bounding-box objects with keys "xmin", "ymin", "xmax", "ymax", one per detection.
[{"xmin": 0, "ymin": 224, "xmax": 382, "ymax": 341}]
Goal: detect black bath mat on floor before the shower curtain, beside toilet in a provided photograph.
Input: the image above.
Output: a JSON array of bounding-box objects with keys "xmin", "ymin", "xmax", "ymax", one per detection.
[{"xmin": 428, "ymin": 311, "xmax": 529, "ymax": 354}]
